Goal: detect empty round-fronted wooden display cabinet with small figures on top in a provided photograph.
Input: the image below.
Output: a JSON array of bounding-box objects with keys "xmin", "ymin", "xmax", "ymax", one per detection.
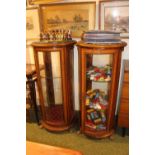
[{"xmin": 32, "ymin": 41, "xmax": 76, "ymax": 131}]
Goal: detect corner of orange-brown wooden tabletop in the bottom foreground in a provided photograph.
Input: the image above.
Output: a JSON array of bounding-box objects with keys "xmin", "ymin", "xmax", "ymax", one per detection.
[{"xmin": 26, "ymin": 141, "xmax": 82, "ymax": 155}]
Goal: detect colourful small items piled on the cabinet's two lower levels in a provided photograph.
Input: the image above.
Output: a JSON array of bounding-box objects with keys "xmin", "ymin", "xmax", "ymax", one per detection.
[{"xmin": 85, "ymin": 89, "xmax": 108, "ymax": 130}]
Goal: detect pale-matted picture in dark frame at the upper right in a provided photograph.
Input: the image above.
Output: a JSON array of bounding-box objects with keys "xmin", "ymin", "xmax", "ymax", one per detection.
[{"xmin": 99, "ymin": 1, "xmax": 129, "ymax": 38}]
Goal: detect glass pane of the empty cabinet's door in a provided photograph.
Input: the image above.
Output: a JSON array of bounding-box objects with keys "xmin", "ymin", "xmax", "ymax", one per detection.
[{"xmin": 38, "ymin": 51, "xmax": 64, "ymax": 121}]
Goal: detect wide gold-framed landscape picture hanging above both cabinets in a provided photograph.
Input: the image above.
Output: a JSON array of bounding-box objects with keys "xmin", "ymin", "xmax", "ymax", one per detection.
[{"xmin": 40, "ymin": 2, "xmax": 96, "ymax": 38}]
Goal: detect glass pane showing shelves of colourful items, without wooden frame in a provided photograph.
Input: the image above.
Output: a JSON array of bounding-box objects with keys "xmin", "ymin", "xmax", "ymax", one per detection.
[{"xmin": 85, "ymin": 54, "xmax": 113, "ymax": 131}]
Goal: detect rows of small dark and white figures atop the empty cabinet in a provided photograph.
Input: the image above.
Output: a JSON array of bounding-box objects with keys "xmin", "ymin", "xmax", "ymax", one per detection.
[{"xmin": 40, "ymin": 29, "xmax": 72, "ymax": 42}]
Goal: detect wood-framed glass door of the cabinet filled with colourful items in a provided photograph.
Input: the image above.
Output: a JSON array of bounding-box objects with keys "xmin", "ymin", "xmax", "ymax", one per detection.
[{"xmin": 81, "ymin": 49, "xmax": 113, "ymax": 134}]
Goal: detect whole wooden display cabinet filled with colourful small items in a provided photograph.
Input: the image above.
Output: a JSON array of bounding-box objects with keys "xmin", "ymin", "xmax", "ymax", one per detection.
[{"xmin": 77, "ymin": 41, "xmax": 126, "ymax": 138}]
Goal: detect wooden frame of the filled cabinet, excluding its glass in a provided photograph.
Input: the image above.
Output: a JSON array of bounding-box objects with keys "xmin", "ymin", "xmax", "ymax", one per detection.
[{"xmin": 76, "ymin": 41, "xmax": 127, "ymax": 138}]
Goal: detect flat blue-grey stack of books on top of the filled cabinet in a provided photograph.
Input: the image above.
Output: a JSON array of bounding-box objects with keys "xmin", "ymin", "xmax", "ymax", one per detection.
[{"xmin": 81, "ymin": 30, "xmax": 121, "ymax": 43}]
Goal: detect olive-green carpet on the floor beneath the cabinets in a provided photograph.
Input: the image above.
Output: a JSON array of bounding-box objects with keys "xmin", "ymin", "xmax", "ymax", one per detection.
[{"xmin": 26, "ymin": 123, "xmax": 129, "ymax": 155}]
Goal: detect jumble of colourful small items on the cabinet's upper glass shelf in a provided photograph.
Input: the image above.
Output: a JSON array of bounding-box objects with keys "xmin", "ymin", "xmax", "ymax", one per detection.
[{"xmin": 87, "ymin": 65, "xmax": 112, "ymax": 82}]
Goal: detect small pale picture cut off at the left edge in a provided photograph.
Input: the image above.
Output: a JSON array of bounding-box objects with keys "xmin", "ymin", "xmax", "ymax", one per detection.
[{"xmin": 26, "ymin": 8, "xmax": 40, "ymax": 40}]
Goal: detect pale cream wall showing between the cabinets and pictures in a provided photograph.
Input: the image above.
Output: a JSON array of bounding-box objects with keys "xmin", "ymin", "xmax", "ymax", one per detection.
[{"xmin": 26, "ymin": 0, "xmax": 129, "ymax": 112}]
